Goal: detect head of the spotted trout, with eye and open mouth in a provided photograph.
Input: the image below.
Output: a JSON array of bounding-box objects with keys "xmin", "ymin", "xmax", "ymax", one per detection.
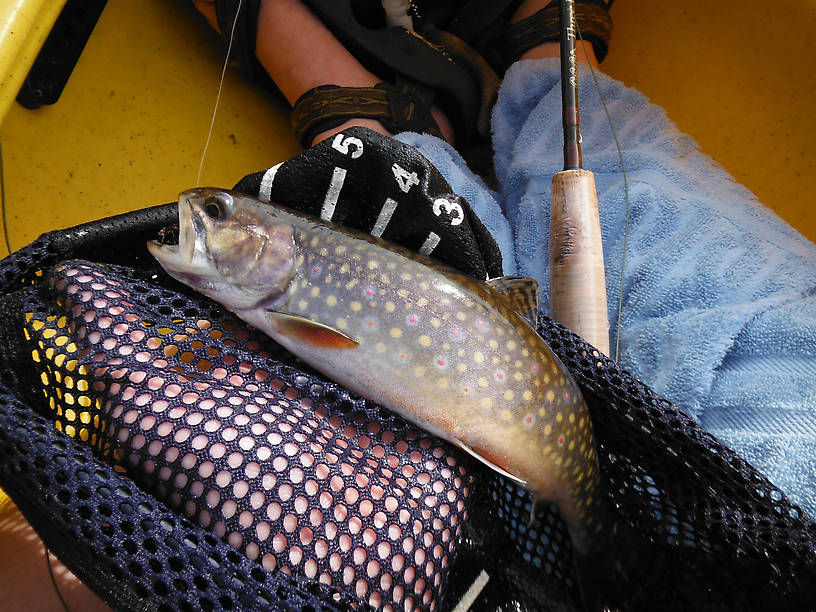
[{"xmin": 147, "ymin": 187, "xmax": 295, "ymax": 310}]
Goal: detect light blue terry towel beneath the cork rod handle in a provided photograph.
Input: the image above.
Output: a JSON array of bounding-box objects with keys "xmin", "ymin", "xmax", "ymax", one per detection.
[{"xmin": 399, "ymin": 60, "xmax": 816, "ymax": 517}]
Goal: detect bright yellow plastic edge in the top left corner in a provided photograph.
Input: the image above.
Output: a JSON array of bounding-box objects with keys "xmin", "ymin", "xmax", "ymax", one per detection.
[{"xmin": 0, "ymin": 0, "xmax": 65, "ymax": 123}]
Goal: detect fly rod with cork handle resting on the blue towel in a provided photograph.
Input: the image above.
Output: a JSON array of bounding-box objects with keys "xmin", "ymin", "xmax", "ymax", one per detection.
[{"xmin": 550, "ymin": 0, "xmax": 609, "ymax": 355}]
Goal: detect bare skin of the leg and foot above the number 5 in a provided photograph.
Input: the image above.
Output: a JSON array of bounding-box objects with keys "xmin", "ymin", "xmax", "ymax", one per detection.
[{"xmin": 193, "ymin": 0, "xmax": 453, "ymax": 145}]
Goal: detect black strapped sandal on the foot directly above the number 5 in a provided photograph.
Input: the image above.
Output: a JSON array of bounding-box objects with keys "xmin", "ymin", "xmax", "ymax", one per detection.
[{"xmin": 210, "ymin": 0, "xmax": 499, "ymax": 146}]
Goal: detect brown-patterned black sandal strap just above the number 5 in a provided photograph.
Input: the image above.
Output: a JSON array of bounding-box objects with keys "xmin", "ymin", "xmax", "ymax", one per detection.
[{"xmin": 289, "ymin": 80, "xmax": 442, "ymax": 148}]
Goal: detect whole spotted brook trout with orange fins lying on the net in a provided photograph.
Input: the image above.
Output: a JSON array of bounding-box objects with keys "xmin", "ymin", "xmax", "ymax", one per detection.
[{"xmin": 147, "ymin": 188, "xmax": 614, "ymax": 610}]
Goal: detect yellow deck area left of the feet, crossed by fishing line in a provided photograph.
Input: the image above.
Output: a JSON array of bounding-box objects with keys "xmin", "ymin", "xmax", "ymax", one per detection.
[{"xmin": 0, "ymin": 0, "xmax": 300, "ymax": 249}]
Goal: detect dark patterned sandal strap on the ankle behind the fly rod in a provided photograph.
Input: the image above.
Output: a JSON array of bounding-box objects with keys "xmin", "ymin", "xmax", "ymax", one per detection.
[{"xmin": 504, "ymin": 0, "xmax": 612, "ymax": 66}]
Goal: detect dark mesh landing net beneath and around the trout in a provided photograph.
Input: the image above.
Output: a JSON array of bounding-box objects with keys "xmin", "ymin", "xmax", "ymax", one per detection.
[{"xmin": 0, "ymin": 207, "xmax": 816, "ymax": 610}]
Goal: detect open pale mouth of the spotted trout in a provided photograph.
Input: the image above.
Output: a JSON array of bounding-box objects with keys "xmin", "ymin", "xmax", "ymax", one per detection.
[{"xmin": 147, "ymin": 190, "xmax": 211, "ymax": 278}]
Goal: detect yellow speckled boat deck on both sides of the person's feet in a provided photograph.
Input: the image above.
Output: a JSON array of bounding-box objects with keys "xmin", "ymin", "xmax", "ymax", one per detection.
[{"xmin": 0, "ymin": 0, "xmax": 816, "ymax": 249}]
